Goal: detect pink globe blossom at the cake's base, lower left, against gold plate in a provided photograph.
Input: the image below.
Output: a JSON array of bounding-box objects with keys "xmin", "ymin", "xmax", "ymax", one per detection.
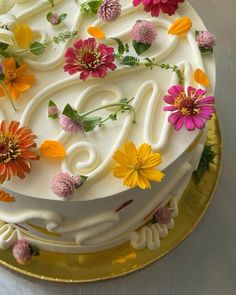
[{"xmin": 12, "ymin": 240, "xmax": 32, "ymax": 265}]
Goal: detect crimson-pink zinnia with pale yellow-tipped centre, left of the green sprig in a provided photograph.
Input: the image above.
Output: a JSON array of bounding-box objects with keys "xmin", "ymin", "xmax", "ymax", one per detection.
[{"xmin": 64, "ymin": 38, "xmax": 116, "ymax": 81}]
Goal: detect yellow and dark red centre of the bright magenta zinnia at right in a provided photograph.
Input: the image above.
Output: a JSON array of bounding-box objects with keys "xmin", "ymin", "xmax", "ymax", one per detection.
[{"xmin": 174, "ymin": 92, "xmax": 200, "ymax": 116}]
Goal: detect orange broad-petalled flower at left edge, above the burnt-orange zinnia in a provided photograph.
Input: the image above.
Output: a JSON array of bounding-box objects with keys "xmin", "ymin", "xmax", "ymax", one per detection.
[{"xmin": 0, "ymin": 57, "xmax": 36, "ymax": 99}]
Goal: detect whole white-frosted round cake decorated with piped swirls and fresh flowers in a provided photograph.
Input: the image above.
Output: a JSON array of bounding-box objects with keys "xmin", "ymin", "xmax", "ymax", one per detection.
[{"xmin": 0, "ymin": 0, "xmax": 215, "ymax": 263}]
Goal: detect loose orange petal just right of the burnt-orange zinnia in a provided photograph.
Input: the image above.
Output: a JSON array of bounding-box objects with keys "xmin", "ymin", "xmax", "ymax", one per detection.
[{"xmin": 39, "ymin": 140, "xmax": 66, "ymax": 159}]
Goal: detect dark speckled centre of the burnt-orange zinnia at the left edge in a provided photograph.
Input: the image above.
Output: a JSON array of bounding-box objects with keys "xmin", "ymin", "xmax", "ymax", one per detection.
[{"xmin": 0, "ymin": 136, "xmax": 20, "ymax": 164}]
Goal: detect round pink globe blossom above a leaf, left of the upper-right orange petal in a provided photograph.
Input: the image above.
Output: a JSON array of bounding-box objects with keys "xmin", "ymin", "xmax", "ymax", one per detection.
[{"xmin": 131, "ymin": 20, "xmax": 157, "ymax": 44}]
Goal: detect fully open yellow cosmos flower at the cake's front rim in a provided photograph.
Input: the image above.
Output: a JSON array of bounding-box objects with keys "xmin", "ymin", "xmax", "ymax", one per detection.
[{"xmin": 112, "ymin": 142, "xmax": 165, "ymax": 189}]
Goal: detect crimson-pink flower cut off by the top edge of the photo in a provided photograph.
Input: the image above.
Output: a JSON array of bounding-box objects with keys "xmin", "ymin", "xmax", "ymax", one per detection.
[{"xmin": 133, "ymin": 0, "xmax": 184, "ymax": 16}]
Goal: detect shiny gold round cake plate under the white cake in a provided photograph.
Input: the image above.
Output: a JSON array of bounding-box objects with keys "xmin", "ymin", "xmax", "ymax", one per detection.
[{"xmin": 0, "ymin": 116, "xmax": 222, "ymax": 283}]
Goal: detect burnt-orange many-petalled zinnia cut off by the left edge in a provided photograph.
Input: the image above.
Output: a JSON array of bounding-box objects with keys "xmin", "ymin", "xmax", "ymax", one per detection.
[{"xmin": 0, "ymin": 121, "xmax": 39, "ymax": 183}]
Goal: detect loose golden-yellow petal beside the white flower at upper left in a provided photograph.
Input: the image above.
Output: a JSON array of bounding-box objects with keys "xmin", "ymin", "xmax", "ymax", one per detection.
[{"xmin": 14, "ymin": 24, "xmax": 33, "ymax": 49}]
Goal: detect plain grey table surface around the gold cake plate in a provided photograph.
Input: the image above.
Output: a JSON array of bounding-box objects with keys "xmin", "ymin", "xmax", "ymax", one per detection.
[{"xmin": 0, "ymin": 0, "xmax": 236, "ymax": 295}]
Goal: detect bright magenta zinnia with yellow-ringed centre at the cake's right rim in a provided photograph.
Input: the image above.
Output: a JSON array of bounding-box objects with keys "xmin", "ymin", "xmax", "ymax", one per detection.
[{"xmin": 164, "ymin": 85, "xmax": 215, "ymax": 131}]
